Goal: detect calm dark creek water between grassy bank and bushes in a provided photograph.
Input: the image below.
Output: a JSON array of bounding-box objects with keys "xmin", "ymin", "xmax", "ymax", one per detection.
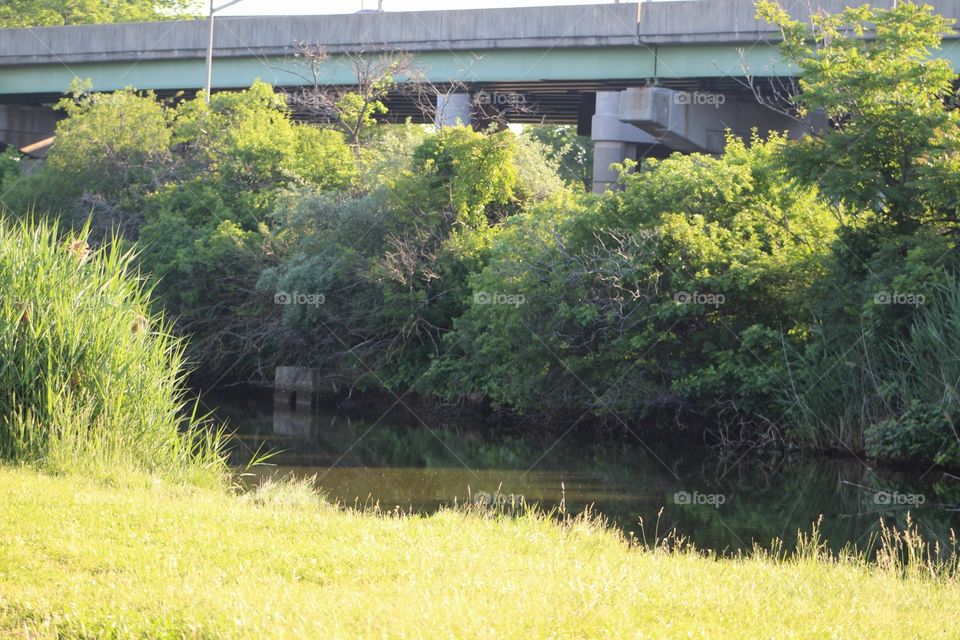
[{"xmin": 199, "ymin": 392, "xmax": 960, "ymax": 551}]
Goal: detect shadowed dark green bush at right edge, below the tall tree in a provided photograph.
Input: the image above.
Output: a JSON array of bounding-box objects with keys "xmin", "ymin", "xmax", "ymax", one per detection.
[{"xmin": 781, "ymin": 238, "xmax": 960, "ymax": 451}]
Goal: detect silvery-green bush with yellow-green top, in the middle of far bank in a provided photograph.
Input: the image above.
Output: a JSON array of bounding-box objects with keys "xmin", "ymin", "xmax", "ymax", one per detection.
[{"xmin": 260, "ymin": 127, "xmax": 563, "ymax": 384}]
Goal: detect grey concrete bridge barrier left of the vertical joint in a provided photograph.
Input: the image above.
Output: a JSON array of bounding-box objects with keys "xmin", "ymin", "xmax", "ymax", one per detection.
[{"xmin": 0, "ymin": 3, "xmax": 638, "ymax": 65}]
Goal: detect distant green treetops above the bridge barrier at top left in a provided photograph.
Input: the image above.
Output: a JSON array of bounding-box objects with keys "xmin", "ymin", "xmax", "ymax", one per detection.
[{"xmin": 0, "ymin": 0, "xmax": 195, "ymax": 28}]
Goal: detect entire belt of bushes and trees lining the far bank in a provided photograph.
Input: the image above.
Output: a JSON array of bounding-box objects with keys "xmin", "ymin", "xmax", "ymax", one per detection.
[{"xmin": 0, "ymin": 3, "xmax": 960, "ymax": 464}]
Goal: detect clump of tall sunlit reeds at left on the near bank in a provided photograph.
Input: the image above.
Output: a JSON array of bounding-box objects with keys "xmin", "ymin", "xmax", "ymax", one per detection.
[{"xmin": 0, "ymin": 219, "xmax": 226, "ymax": 485}]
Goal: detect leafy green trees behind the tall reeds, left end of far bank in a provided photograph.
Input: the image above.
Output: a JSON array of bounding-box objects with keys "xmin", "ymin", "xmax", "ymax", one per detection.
[{"xmin": 3, "ymin": 82, "xmax": 358, "ymax": 380}]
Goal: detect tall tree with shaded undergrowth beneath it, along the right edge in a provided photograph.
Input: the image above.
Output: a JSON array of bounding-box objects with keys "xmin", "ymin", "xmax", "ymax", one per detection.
[{"xmin": 759, "ymin": 3, "xmax": 960, "ymax": 461}]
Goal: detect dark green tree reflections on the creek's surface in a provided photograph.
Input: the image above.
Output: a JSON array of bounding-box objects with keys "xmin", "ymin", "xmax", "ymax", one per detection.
[{"xmin": 204, "ymin": 388, "xmax": 960, "ymax": 550}]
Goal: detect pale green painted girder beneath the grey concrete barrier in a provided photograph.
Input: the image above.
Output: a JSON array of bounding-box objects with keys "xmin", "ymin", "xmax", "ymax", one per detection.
[{"xmin": 0, "ymin": 40, "xmax": 960, "ymax": 95}]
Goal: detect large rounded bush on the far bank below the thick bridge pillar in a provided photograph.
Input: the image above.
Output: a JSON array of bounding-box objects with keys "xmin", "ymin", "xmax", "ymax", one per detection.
[{"xmin": 430, "ymin": 137, "xmax": 835, "ymax": 419}]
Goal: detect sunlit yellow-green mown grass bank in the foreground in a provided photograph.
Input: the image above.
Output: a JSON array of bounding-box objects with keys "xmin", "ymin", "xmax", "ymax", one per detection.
[{"xmin": 0, "ymin": 467, "xmax": 960, "ymax": 638}]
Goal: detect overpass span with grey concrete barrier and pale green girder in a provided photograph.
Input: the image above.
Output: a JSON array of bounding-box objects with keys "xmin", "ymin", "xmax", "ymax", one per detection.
[{"xmin": 0, "ymin": 0, "xmax": 960, "ymax": 98}]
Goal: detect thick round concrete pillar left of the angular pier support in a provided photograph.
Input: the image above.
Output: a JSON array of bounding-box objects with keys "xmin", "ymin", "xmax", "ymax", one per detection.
[{"xmin": 591, "ymin": 91, "xmax": 656, "ymax": 193}]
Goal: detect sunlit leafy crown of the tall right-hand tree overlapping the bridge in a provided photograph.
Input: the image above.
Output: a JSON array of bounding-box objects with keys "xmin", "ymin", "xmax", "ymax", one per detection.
[{"xmin": 758, "ymin": 0, "xmax": 960, "ymax": 232}]
